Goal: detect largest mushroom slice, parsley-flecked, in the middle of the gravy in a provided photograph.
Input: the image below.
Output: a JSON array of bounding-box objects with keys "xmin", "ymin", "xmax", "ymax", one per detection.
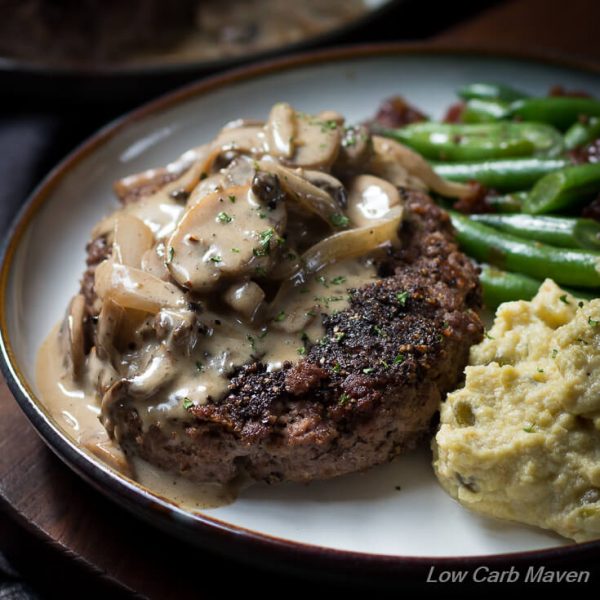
[{"xmin": 167, "ymin": 186, "xmax": 286, "ymax": 292}]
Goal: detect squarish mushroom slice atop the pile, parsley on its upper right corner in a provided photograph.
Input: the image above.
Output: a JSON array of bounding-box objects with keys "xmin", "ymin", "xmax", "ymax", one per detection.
[{"xmin": 286, "ymin": 113, "xmax": 343, "ymax": 170}]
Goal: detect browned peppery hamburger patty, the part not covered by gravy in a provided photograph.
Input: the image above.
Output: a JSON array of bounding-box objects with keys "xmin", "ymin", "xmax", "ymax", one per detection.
[{"xmin": 98, "ymin": 191, "xmax": 483, "ymax": 482}]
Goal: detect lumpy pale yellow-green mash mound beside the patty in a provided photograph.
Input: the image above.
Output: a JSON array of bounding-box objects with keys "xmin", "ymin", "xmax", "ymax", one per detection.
[{"xmin": 433, "ymin": 280, "xmax": 600, "ymax": 541}]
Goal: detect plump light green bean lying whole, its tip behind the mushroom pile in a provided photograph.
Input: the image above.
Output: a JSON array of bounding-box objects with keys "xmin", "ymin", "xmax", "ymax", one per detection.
[{"xmin": 382, "ymin": 122, "xmax": 563, "ymax": 161}]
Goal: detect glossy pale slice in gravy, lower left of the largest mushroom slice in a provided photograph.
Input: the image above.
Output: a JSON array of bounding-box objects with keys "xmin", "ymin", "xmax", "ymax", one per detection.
[{"xmin": 94, "ymin": 259, "xmax": 187, "ymax": 314}]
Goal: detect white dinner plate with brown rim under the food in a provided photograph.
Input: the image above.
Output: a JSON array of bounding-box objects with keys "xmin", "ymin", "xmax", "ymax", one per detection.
[{"xmin": 0, "ymin": 46, "xmax": 600, "ymax": 565}]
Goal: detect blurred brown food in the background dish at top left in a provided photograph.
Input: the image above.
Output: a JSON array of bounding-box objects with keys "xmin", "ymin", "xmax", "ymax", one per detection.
[{"xmin": 0, "ymin": 0, "xmax": 376, "ymax": 68}]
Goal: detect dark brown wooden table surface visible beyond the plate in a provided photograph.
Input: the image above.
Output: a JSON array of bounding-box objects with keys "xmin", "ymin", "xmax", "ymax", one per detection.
[{"xmin": 0, "ymin": 0, "xmax": 600, "ymax": 598}]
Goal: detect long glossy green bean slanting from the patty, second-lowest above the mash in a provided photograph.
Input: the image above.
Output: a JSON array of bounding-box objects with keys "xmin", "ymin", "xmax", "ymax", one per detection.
[{"xmin": 449, "ymin": 211, "xmax": 600, "ymax": 288}]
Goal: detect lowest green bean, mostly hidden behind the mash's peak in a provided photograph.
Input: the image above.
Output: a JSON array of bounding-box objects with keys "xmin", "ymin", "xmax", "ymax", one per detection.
[{"xmin": 479, "ymin": 264, "xmax": 598, "ymax": 308}]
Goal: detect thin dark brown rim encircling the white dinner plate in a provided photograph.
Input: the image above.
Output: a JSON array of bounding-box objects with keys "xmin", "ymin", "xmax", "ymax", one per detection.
[{"xmin": 0, "ymin": 43, "xmax": 600, "ymax": 574}]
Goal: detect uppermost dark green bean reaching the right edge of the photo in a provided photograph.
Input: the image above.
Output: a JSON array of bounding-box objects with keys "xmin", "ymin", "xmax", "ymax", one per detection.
[{"xmin": 508, "ymin": 96, "xmax": 600, "ymax": 130}]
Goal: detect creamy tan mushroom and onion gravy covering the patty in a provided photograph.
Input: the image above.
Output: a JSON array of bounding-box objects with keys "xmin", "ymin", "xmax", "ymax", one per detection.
[{"xmin": 37, "ymin": 103, "xmax": 466, "ymax": 509}]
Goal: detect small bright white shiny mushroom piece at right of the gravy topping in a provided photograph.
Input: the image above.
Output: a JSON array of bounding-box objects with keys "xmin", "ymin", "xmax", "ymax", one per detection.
[{"xmin": 346, "ymin": 175, "xmax": 400, "ymax": 227}]
